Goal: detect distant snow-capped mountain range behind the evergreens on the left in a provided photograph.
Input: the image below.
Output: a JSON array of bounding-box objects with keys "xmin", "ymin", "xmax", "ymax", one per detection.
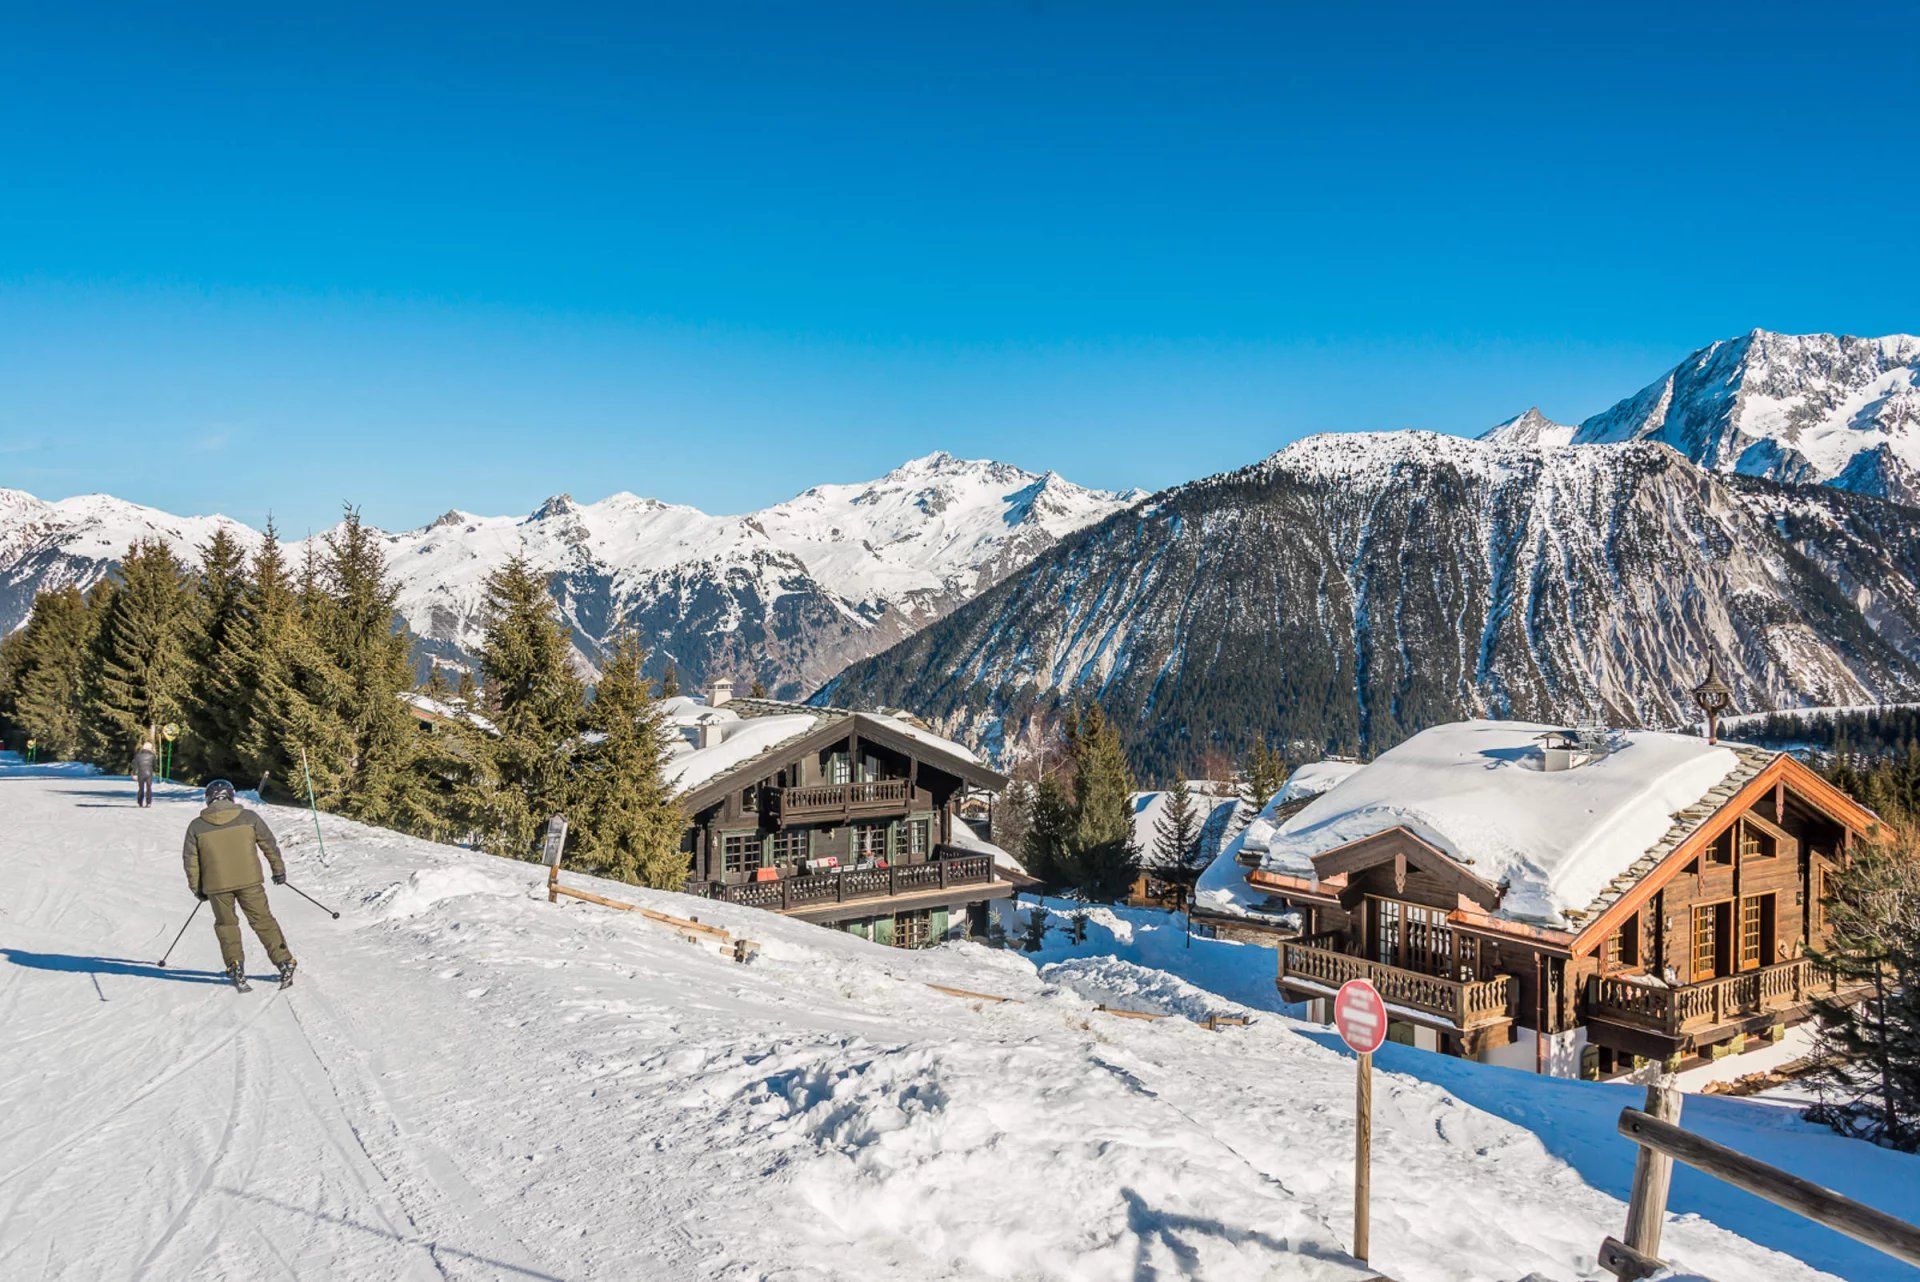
[{"xmin": 0, "ymin": 453, "xmax": 1139, "ymax": 695}]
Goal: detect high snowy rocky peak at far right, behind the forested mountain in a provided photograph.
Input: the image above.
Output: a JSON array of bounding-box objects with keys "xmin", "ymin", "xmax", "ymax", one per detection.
[{"xmin": 1572, "ymin": 330, "xmax": 1920, "ymax": 503}]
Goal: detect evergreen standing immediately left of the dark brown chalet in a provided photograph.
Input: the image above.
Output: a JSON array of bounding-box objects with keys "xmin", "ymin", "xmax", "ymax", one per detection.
[{"xmin": 572, "ymin": 635, "xmax": 687, "ymax": 890}]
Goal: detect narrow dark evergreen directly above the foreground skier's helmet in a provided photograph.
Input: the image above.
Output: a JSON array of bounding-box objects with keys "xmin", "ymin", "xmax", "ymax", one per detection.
[{"xmin": 179, "ymin": 528, "xmax": 252, "ymax": 779}]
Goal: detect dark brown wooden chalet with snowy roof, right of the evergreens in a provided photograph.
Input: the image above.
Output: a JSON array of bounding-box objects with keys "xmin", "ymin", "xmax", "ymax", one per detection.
[{"xmin": 666, "ymin": 681, "xmax": 1014, "ymax": 948}]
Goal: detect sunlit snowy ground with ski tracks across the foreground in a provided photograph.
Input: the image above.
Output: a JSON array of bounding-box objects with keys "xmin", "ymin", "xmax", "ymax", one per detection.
[{"xmin": 0, "ymin": 764, "xmax": 1920, "ymax": 1282}]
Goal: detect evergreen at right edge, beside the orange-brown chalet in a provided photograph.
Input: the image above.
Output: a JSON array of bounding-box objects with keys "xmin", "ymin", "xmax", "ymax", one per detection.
[{"xmin": 1807, "ymin": 825, "xmax": 1920, "ymax": 1150}]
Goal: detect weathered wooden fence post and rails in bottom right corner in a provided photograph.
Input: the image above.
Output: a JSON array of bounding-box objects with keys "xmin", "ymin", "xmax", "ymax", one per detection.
[{"xmin": 1599, "ymin": 1086, "xmax": 1920, "ymax": 1282}]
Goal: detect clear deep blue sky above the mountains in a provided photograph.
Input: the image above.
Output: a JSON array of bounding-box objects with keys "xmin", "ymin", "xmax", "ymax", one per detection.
[{"xmin": 0, "ymin": 2, "xmax": 1920, "ymax": 534}]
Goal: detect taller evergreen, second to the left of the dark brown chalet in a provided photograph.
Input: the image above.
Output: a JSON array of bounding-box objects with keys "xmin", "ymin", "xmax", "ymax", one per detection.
[{"xmin": 478, "ymin": 557, "xmax": 584, "ymax": 858}]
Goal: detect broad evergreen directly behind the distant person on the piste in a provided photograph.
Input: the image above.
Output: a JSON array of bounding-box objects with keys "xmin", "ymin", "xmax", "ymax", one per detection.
[{"xmin": 83, "ymin": 539, "xmax": 188, "ymax": 770}]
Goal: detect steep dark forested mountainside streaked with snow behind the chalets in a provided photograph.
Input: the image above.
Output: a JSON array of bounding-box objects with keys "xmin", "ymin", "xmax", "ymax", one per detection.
[{"xmin": 818, "ymin": 432, "xmax": 1920, "ymax": 777}]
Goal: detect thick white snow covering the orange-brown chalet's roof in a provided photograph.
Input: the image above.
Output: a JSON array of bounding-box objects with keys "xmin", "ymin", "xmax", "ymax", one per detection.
[{"xmin": 1246, "ymin": 722, "xmax": 1741, "ymax": 925}]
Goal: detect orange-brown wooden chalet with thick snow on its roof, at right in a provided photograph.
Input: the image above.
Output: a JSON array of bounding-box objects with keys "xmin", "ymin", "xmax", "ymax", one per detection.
[{"xmin": 1200, "ymin": 722, "xmax": 1876, "ymax": 1077}]
